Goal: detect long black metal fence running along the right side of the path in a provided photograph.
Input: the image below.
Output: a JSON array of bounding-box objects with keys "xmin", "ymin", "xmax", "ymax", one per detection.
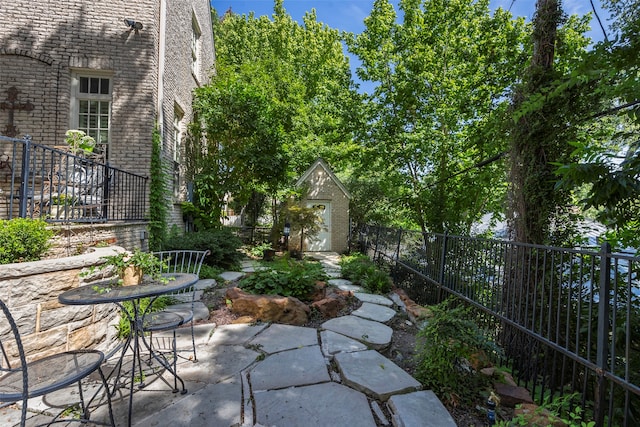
[{"xmin": 354, "ymin": 226, "xmax": 640, "ymax": 426}]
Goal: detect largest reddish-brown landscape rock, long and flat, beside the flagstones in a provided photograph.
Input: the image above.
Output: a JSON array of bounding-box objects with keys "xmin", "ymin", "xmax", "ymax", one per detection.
[{"xmin": 226, "ymin": 288, "xmax": 311, "ymax": 326}]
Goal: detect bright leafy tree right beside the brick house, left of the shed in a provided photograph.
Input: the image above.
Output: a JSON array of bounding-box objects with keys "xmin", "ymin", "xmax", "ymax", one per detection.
[{"xmin": 191, "ymin": 0, "xmax": 358, "ymax": 227}]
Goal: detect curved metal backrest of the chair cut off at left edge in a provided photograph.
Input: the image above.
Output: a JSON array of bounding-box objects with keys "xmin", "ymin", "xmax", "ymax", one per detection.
[{"xmin": 0, "ymin": 300, "xmax": 29, "ymax": 420}]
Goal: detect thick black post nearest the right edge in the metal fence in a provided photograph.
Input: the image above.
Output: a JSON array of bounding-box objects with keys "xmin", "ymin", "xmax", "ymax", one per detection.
[{"xmin": 594, "ymin": 242, "xmax": 611, "ymax": 426}]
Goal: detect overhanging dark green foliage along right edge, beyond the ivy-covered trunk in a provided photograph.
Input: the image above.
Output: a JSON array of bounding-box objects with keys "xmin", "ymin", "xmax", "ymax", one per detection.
[{"xmin": 555, "ymin": 0, "xmax": 640, "ymax": 247}]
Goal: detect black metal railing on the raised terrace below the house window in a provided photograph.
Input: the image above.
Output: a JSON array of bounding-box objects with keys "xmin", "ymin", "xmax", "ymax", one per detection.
[{"xmin": 0, "ymin": 136, "xmax": 147, "ymax": 223}]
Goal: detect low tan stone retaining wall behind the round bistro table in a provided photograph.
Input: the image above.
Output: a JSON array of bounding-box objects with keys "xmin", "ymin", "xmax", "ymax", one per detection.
[{"xmin": 0, "ymin": 246, "xmax": 123, "ymax": 360}]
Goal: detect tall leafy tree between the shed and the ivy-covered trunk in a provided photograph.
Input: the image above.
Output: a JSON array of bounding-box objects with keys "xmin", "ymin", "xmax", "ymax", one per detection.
[{"xmin": 348, "ymin": 0, "xmax": 525, "ymax": 233}]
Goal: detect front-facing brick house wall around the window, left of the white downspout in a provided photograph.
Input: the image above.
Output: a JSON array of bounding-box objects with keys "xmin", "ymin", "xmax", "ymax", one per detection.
[{"xmin": 0, "ymin": 0, "xmax": 159, "ymax": 170}]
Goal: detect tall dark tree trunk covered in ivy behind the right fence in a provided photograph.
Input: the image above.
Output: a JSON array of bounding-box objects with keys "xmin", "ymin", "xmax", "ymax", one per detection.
[{"xmin": 509, "ymin": 0, "xmax": 598, "ymax": 245}]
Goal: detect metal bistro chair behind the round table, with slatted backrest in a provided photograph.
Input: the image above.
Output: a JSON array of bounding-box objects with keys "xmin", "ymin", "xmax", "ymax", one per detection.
[{"xmin": 143, "ymin": 250, "xmax": 210, "ymax": 369}]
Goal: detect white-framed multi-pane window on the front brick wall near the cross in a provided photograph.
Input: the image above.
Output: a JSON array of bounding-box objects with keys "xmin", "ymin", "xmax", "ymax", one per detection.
[{"xmin": 69, "ymin": 70, "xmax": 114, "ymax": 150}]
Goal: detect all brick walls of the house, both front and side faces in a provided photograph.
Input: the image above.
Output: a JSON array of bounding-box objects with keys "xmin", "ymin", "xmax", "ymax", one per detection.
[{"xmin": 0, "ymin": 0, "xmax": 214, "ymax": 232}]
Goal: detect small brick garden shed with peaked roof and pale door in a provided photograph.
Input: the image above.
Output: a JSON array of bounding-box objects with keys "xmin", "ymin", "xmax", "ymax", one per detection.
[{"xmin": 291, "ymin": 158, "xmax": 351, "ymax": 253}]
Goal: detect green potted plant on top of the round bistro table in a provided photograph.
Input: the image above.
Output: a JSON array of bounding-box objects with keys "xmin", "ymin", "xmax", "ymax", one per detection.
[{"xmin": 98, "ymin": 249, "xmax": 167, "ymax": 286}]
